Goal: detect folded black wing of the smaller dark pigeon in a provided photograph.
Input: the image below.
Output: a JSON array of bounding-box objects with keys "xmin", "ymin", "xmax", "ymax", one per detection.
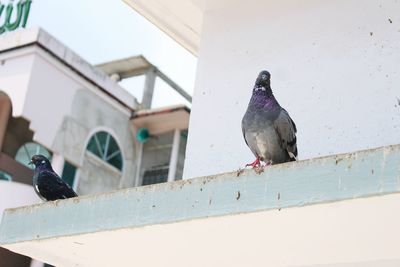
[{"xmin": 38, "ymin": 171, "xmax": 78, "ymax": 200}]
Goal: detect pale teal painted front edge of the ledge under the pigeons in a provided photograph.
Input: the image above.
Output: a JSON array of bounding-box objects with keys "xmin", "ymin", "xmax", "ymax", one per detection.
[{"xmin": 0, "ymin": 145, "xmax": 400, "ymax": 245}]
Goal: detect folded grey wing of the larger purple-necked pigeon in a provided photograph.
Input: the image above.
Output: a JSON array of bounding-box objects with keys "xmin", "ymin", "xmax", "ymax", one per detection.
[{"xmin": 274, "ymin": 109, "xmax": 297, "ymax": 161}]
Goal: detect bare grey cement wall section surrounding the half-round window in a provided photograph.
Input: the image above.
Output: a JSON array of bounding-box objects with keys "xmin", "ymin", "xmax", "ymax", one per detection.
[{"xmin": 53, "ymin": 89, "xmax": 137, "ymax": 194}]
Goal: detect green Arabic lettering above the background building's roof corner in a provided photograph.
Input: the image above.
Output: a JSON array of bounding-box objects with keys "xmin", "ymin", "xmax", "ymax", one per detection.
[{"xmin": 0, "ymin": 0, "xmax": 32, "ymax": 34}]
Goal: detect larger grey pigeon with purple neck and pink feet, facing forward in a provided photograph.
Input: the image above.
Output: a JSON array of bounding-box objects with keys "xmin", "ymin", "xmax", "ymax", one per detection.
[{"xmin": 242, "ymin": 70, "xmax": 297, "ymax": 168}]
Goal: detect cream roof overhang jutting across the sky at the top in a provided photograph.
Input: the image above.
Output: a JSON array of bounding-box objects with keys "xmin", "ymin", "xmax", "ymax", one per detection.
[{"xmin": 123, "ymin": 0, "xmax": 203, "ymax": 55}]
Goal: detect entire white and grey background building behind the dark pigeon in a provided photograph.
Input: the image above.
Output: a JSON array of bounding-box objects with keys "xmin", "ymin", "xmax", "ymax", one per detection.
[{"xmin": 0, "ymin": 29, "xmax": 190, "ymax": 266}]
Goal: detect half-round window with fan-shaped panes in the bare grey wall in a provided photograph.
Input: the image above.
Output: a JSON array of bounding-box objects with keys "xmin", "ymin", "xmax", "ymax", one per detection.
[{"xmin": 86, "ymin": 131, "xmax": 122, "ymax": 171}]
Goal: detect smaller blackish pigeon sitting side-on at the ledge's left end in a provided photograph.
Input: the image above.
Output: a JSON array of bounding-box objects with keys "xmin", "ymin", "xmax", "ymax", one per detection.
[{"xmin": 29, "ymin": 155, "xmax": 78, "ymax": 201}]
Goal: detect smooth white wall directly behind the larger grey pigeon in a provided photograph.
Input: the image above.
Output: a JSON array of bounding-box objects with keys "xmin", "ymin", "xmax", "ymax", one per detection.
[{"xmin": 184, "ymin": 0, "xmax": 400, "ymax": 178}]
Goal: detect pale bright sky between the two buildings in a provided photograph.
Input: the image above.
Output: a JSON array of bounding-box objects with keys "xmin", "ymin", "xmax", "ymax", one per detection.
[{"xmin": 28, "ymin": 0, "xmax": 197, "ymax": 107}]
